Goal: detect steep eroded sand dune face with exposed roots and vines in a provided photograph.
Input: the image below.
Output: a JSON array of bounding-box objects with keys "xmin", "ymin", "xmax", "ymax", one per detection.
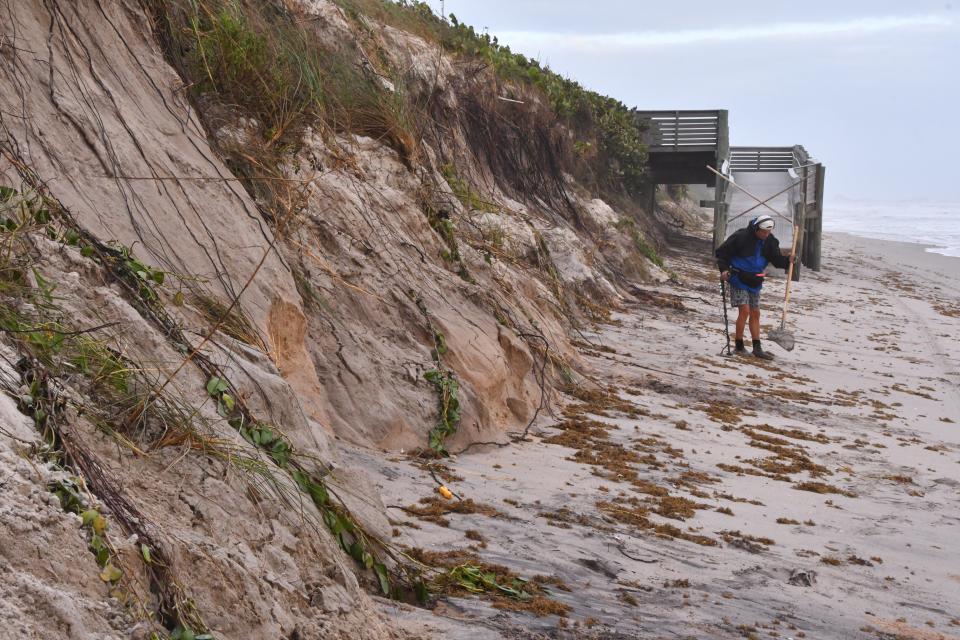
[{"xmin": 0, "ymin": 0, "xmax": 654, "ymax": 640}]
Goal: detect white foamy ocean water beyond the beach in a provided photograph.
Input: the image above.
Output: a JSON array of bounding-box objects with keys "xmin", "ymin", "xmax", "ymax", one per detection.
[{"xmin": 823, "ymin": 198, "xmax": 960, "ymax": 257}]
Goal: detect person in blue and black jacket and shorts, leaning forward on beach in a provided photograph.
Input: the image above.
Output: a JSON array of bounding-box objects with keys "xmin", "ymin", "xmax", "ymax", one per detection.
[{"xmin": 716, "ymin": 215, "xmax": 793, "ymax": 360}]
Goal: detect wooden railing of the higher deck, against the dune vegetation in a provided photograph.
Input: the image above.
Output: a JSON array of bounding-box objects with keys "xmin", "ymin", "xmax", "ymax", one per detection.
[{"xmin": 634, "ymin": 111, "xmax": 725, "ymax": 153}]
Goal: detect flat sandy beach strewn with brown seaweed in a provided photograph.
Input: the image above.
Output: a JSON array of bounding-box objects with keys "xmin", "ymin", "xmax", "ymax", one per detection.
[{"xmin": 354, "ymin": 234, "xmax": 960, "ymax": 639}]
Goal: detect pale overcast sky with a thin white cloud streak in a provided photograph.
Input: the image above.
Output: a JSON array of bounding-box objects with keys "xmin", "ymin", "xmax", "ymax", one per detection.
[{"xmin": 430, "ymin": 0, "xmax": 960, "ymax": 202}]
